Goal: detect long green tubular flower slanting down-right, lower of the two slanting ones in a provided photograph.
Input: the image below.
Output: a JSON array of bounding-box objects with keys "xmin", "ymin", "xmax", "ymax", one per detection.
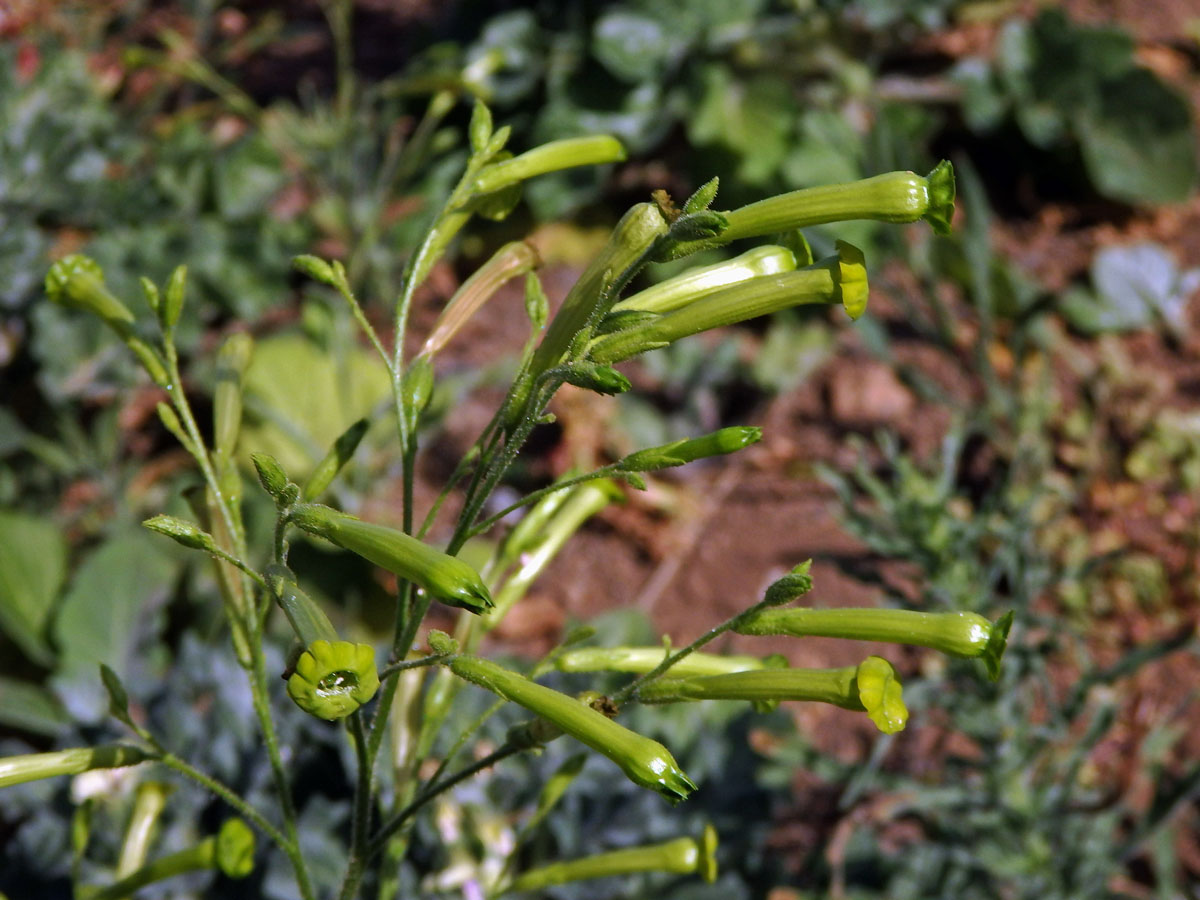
[{"xmin": 450, "ymin": 656, "xmax": 696, "ymax": 803}]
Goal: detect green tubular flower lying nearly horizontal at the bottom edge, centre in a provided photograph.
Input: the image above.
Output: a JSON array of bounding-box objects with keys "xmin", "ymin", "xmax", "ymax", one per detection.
[{"xmin": 504, "ymin": 824, "xmax": 716, "ymax": 893}]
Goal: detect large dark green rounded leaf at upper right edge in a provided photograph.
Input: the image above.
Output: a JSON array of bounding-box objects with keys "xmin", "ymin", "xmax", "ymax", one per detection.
[{"xmin": 1076, "ymin": 68, "xmax": 1196, "ymax": 204}]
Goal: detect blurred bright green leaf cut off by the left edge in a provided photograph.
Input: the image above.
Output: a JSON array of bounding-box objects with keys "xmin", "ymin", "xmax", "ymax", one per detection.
[{"xmin": 0, "ymin": 511, "xmax": 67, "ymax": 665}]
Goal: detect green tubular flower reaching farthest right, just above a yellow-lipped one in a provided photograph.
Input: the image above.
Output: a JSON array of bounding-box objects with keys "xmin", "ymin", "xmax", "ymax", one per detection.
[{"xmin": 734, "ymin": 608, "xmax": 1013, "ymax": 680}]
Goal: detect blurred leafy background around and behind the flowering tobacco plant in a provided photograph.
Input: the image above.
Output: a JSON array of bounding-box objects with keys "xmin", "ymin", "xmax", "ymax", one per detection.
[{"xmin": 0, "ymin": 0, "xmax": 1200, "ymax": 900}]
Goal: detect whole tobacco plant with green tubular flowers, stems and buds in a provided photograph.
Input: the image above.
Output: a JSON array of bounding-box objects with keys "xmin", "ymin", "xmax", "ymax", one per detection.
[{"xmin": 0, "ymin": 103, "xmax": 1010, "ymax": 900}]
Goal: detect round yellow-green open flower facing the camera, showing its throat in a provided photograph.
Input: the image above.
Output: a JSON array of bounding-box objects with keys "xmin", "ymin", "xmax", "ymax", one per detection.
[{"xmin": 288, "ymin": 641, "xmax": 379, "ymax": 721}]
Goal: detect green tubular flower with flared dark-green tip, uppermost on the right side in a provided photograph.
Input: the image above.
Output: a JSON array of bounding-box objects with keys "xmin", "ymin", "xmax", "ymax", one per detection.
[{"xmin": 720, "ymin": 160, "xmax": 954, "ymax": 244}]
